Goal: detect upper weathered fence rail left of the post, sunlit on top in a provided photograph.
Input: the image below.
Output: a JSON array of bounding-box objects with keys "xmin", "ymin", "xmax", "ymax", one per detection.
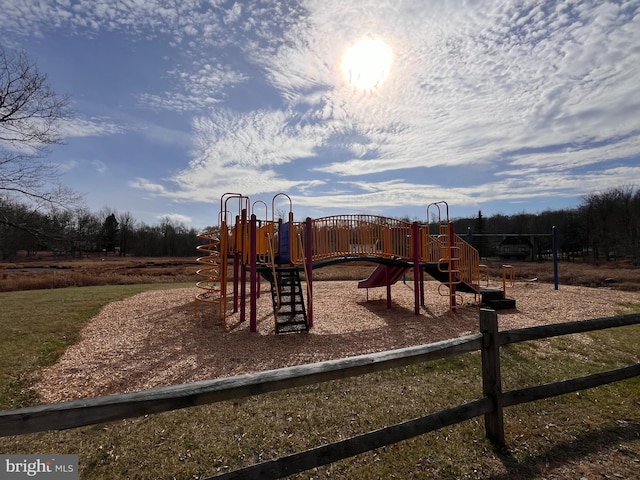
[{"xmin": 0, "ymin": 334, "xmax": 482, "ymax": 437}]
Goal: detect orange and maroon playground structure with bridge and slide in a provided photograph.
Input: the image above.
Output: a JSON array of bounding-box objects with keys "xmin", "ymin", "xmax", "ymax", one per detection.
[{"xmin": 194, "ymin": 193, "xmax": 504, "ymax": 333}]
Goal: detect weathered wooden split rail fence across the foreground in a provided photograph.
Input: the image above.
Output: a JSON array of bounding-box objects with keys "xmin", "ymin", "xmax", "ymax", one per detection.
[{"xmin": 0, "ymin": 309, "xmax": 640, "ymax": 479}]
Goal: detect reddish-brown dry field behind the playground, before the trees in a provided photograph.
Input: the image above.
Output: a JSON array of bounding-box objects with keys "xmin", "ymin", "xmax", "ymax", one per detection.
[{"xmin": 0, "ymin": 254, "xmax": 640, "ymax": 292}]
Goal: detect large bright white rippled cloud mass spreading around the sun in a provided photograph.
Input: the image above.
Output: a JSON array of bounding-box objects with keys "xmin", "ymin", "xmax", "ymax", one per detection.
[{"xmin": 156, "ymin": 2, "xmax": 640, "ymax": 210}]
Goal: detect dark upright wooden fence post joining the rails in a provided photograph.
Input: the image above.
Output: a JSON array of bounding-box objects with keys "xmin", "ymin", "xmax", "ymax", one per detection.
[{"xmin": 480, "ymin": 308, "xmax": 505, "ymax": 447}]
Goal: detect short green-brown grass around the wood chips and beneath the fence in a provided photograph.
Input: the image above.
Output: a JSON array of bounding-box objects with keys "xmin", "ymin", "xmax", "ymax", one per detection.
[{"xmin": 0, "ymin": 284, "xmax": 640, "ymax": 480}]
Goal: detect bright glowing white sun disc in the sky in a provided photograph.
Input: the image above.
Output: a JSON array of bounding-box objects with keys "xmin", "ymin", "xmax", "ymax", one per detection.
[{"xmin": 340, "ymin": 38, "xmax": 393, "ymax": 90}]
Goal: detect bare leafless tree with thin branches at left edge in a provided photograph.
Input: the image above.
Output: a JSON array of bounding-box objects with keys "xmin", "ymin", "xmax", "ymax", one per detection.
[{"xmin": 0, "ymin": 46, "xmax": 78, "ymax": 205}]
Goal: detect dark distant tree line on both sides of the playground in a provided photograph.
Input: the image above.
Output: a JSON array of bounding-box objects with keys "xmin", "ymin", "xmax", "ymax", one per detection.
[{"xmin": 0, "ymin": 186, "xmax": 640, "ymax": 264}]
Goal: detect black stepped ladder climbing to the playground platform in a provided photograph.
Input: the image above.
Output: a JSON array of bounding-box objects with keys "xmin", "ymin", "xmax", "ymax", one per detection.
[{"xmin": 261, "ymin": 266, "xmax": 309, "ymax": 334}]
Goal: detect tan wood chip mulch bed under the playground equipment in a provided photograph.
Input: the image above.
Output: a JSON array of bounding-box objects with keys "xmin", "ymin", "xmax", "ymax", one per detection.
[{"xmin": 37, "ymin": 281, "xmax": 640, "ymax": 402}]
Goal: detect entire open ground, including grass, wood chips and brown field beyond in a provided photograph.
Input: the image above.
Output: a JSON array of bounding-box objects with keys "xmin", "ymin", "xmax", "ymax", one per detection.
[{"xmin": 0, "ymin": 257, "xmax": 640, "ymax": 480}]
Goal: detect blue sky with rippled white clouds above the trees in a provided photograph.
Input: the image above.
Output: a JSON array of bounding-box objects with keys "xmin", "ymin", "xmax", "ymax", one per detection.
[{"xmin": 0, "ymin": 0, "xmax": 640, "ymax": 228}]
